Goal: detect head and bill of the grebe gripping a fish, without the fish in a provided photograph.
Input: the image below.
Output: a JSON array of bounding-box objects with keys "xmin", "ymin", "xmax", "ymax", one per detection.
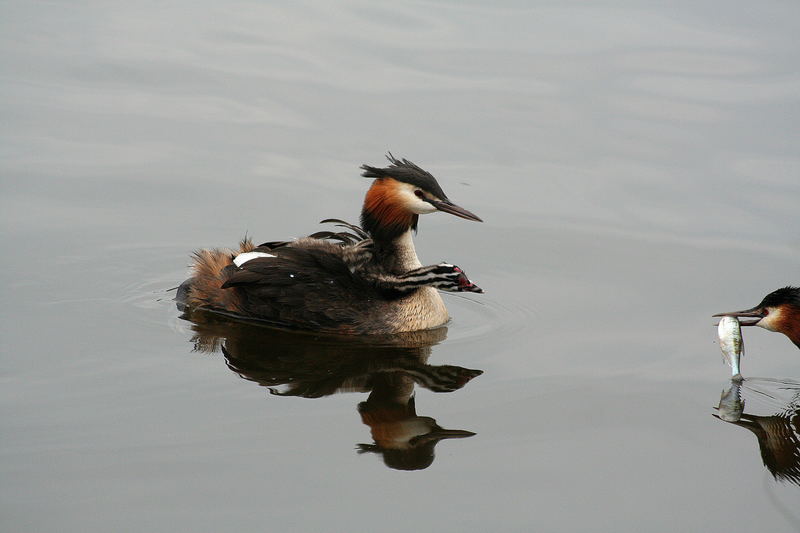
[{"xmin": 712, "ymin": 287, "xmax": 800, "ymax": 348}]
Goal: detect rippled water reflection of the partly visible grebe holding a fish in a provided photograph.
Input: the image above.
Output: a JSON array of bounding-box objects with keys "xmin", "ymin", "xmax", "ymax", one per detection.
[{"xmin": 714, "ymin": 378, "xmax": 800, "ymax": 485}]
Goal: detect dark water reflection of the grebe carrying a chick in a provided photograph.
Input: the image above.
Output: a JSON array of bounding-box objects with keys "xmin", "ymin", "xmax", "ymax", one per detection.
[{"xmin": 182, "ymin": 310, "xmax": 483, "ymax": 470}]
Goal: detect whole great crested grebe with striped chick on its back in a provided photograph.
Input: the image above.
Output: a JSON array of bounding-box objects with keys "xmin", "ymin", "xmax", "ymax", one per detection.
[{"xmin": 177, "ymin": 154, "xmax": 483, "ymax": 335}]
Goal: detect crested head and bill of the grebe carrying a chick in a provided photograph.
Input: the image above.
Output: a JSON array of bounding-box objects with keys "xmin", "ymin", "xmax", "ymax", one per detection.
[{"xmin": 361, "ymin": 153, "xmax": 483, "ymax": 238}]
